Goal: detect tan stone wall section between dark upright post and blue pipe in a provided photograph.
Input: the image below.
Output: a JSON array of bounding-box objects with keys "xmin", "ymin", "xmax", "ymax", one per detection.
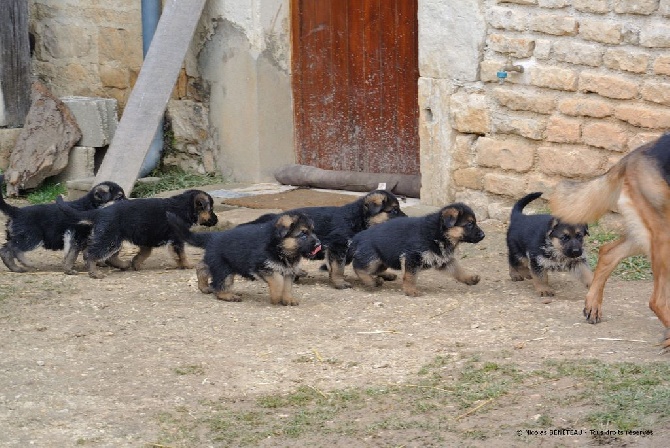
[{"xmin": 30, "ymin": 0, "xmax": 142, "ymax": 111}]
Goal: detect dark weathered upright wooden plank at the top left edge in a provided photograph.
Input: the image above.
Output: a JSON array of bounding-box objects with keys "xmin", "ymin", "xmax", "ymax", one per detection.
[{"xmin": 0, "ymin": 0, "xmax": 30, "ymax": 128}]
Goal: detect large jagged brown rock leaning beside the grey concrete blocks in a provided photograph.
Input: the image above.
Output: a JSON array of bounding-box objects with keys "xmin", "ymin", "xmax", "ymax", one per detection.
[{"xmin": 5, "ymin": 82, "xmax": 81, "ymax": 196}]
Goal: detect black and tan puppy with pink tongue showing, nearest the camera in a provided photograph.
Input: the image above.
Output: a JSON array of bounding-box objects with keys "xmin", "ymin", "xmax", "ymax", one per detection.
[{"xmin": 167, "ymin": 212, "xmax": 321, "ymax": 305}]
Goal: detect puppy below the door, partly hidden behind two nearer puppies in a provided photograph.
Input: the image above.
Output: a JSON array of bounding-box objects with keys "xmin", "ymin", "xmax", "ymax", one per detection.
[{"xmin": 245, "ymin": 190, "xmax": 407, "ymax": 289}]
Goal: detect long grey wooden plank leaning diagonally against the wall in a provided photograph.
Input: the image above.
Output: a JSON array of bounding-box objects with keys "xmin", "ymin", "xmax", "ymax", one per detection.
[{"xmin": 95, "ymin": 0, "xmax": 206, "ymax": 194}]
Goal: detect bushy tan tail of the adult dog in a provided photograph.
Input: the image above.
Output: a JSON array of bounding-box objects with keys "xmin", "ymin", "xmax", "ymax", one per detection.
[{"xmin": 549, "ymin": 156, "xmax": 630, "ymax": 224}]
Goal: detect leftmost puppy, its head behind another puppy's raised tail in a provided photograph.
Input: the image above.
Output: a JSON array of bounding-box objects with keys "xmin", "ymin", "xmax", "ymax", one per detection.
[{"xmin": 0, "ymin": 175, "xmax": 126, "ymax": 274}]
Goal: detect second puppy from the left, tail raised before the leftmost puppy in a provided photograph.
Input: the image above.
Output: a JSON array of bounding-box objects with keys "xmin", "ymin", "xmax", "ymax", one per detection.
[{"xmin": 56, "ymin": 190, "xmax": 218, "ymax": 278}]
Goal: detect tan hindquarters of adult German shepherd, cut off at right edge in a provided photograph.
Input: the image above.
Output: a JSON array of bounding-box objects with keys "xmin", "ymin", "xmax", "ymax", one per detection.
[{"xmin": 550, "ymin": 134, "xmax": 670, "ymax": 352}]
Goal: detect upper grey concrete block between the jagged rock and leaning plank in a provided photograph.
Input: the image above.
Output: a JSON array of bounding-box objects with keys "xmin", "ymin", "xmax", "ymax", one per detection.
[{"xmin": 61, "ymin": 96, "xmax": 118, "ymax": 148}]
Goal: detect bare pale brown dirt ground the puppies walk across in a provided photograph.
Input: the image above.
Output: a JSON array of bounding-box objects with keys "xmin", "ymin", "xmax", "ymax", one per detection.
[{"xmin": 0, "ymin": 190, "xmax": 670, "ymax": 447}]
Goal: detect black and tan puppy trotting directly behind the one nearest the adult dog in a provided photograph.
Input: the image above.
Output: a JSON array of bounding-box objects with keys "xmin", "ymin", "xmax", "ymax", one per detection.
[{"xmin": 349, "ymin": 203, "xmax": 484, "ymax": 296}]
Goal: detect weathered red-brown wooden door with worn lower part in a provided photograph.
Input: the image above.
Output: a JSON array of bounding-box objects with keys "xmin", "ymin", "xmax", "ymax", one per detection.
[{"xmin": 291, "ymin": 0, "xmax": 419, "ymax": 174}]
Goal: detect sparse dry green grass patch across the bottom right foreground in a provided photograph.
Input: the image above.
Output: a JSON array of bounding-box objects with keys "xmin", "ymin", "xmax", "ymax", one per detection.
[{"xmin": 152, "ymin": 356, "xmax": 670, "ymax": 447}]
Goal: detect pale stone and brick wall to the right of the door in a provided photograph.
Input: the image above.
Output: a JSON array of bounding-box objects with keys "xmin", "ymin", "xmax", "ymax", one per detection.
[{"xmin": 419, "ymin": 0, "xmax": 670, "ymax": 219}]
